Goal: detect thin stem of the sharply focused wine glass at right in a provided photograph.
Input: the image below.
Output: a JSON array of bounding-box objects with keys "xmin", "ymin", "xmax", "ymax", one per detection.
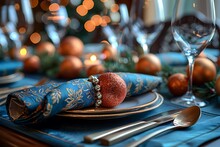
[{"xmin": 187, "ymin": 56, "xmax": 194, "ymax": 96}]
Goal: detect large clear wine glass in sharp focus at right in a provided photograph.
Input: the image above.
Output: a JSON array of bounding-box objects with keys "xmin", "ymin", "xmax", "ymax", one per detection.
[{"xmin": 171, "ymin": 0, "xmax": 216, "ymax": 107}]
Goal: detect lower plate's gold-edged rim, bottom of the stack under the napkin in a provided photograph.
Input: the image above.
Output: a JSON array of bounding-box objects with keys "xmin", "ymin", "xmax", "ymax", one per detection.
[{"xmin": 57, "ymin": 93, "xmax": 163, "ymax": 120}]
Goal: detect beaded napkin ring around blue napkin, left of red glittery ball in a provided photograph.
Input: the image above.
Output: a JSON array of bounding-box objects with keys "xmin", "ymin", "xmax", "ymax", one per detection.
[{"xmin": 88, "ymin": 76, "xmax": 102, "ymax": 107}]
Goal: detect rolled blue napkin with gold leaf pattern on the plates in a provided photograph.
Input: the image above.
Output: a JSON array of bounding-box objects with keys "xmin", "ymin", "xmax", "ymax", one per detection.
[{"xmin": 6, "ymin": 73, "xmax": 162, "ymax": 124}]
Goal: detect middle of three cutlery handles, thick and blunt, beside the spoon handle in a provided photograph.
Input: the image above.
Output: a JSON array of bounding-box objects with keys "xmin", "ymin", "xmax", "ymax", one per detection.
[{"xmin": 100, "ymin": 122, "xmax": 159, "ymax": 146}]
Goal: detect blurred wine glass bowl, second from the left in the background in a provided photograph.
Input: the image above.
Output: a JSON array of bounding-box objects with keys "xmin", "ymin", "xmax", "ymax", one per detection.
[{"xmin": 42, "ymin": 0, "xmax": 69, "ymax": 47}]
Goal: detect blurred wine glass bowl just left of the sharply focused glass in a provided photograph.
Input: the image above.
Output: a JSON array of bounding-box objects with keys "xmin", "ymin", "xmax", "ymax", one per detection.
[{"xmin": 130, "ymin": 0, "xmax": 165, "ymax": 54}]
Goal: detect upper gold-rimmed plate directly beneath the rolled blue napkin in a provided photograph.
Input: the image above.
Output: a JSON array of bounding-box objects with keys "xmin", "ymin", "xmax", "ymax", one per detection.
[{"xmin": 65, "ymin": 92, "xmax": 158, "ymax": 114}]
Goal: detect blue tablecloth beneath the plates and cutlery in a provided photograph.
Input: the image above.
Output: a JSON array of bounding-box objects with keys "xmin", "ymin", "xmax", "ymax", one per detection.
[{"xmin": 0, "ymin": 76, "xmax": 220, "ymax": 147}]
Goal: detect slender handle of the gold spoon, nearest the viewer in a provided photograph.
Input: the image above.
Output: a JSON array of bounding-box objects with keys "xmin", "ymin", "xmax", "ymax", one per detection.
[{"xmin": 127, "ymin": 126, "xmax": 178, "ymax": 147}]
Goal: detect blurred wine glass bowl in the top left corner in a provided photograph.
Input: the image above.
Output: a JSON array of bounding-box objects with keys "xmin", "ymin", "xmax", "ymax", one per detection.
[{"xmin": 0, "ymin": 0, "xmax": 34, "ymax": 58}]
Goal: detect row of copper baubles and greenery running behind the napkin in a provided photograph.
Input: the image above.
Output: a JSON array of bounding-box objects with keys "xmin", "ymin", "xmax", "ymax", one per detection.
[{"xmin": 23, "ymin": 36, "xmax": 220, "ymax": 99}]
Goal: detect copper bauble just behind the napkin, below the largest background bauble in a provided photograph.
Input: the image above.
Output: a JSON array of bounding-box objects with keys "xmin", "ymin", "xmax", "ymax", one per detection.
[{"xmin": 59, "ymin": 56, "xmax": 83, "ymax": 79}]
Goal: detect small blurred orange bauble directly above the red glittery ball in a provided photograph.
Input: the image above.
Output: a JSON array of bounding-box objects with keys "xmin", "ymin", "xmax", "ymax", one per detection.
[{"xmin": 102, "ymin": 45, "xmax": 117, "ymax": 60}]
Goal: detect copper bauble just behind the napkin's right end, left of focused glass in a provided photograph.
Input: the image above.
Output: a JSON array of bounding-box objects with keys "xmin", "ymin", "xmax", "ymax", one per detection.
[{"xmin": 135, "ymin": 53, "xmax": 161, "ymax": 75}]
